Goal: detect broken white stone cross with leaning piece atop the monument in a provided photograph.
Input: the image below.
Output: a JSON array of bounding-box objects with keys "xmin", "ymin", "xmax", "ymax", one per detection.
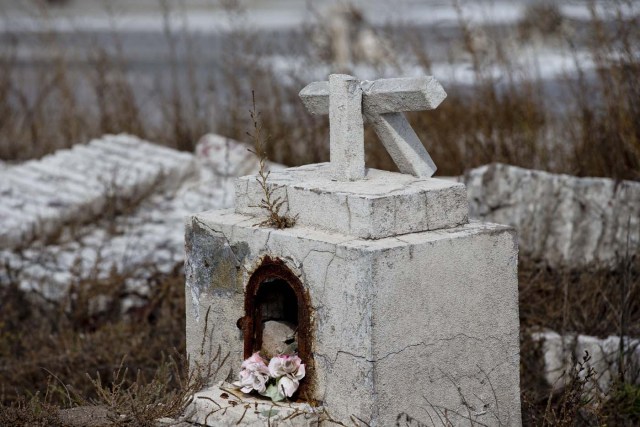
[{"xmin": 300, "ymin": 74, "xmax": 447, "ymax": 181}]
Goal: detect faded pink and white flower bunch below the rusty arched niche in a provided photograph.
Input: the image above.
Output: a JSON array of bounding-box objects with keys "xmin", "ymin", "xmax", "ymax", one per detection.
[{"xmin": 233, "ymin": 352, "xmax": 305, "ymax": 402}]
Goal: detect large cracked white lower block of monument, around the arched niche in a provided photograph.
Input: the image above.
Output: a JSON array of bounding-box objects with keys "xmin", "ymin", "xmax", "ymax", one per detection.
[{"xmin": 186, "ymin": 210, "xmax": 521, "ymax": 426}]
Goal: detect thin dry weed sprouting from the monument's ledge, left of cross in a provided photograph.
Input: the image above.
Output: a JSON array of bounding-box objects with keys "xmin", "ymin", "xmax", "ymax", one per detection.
[{"xmin": 247, "ymin": 91, "xmax": 297, "ymax": 229}]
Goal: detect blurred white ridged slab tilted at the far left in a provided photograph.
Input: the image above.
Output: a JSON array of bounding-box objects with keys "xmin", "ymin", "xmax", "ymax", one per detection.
[{"xmin": 0, "ymin": 135, "xmax": 196, "ymax": 249}]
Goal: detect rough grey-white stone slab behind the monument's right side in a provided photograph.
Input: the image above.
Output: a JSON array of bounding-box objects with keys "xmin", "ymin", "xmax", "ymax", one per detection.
[{"xmin": 464, "ymin": 164, "xmax": 640, "ymax": 267}]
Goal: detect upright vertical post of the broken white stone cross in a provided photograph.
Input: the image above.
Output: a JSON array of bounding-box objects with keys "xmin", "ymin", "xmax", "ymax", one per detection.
[{"xmin": 329, "ymin": 74, "xmax": 365, "ymax": 181}]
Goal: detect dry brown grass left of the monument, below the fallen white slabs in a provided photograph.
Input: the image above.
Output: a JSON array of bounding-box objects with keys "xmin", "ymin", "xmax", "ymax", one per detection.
[{"xmin": 0, "ymin": 270, "xmax": 187, "ymax": 425}]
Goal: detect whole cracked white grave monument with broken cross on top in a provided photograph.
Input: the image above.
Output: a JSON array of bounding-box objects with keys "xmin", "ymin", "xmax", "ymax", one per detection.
[{"xmin": 186, "ymin": 75, "xmax": 521, "ymax": 426}]
